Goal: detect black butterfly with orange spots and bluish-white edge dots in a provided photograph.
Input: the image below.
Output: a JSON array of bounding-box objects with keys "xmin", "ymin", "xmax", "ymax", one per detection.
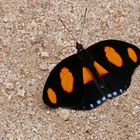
[{"xmin": 43, "ymin": 40, "xmax": 140, "ymax": 110}]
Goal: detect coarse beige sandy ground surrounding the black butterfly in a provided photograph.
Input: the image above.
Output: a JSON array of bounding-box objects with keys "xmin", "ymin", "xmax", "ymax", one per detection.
[{"xmin": 0, "ymin": 0, "xmax": 140, "ymax": 140}]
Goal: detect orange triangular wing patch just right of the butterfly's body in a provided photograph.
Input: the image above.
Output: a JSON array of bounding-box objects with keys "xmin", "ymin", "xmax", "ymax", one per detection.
[{"xmin": 93, "ymin": 61, "xmax": 109, "ymax": 77}]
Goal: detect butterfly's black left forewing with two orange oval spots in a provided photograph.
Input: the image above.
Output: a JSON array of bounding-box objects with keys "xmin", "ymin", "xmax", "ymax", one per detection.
[{"xmin": 43, "ymin": 54, "xmax": 83, "ymax": 108}]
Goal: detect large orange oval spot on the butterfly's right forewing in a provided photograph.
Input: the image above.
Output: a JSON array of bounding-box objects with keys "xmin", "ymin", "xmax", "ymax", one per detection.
[{"xmin": 104, "ymin": 46, "xmax": 123, "ymax": 67}]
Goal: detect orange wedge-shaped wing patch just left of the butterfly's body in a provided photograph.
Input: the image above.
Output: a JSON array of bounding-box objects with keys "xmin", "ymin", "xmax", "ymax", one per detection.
[{"xmin": 82, "ymin": 67, "xmax": 94, "ymax": 84}]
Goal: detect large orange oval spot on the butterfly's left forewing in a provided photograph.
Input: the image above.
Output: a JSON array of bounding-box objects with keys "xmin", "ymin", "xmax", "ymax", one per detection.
[{"xmin": 60, "ymin": 67, "xmax": 74, "ymax": 93}]
